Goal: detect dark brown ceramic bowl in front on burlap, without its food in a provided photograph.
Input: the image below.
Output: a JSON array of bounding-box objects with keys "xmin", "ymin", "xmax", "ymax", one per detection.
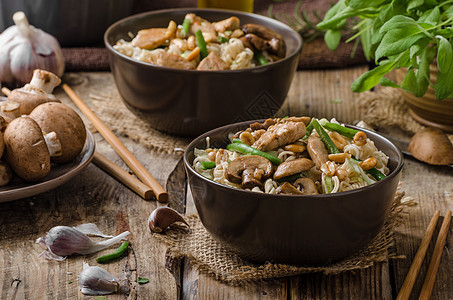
[{"xmin": 184, "ymin": 122, "xmax": 404, "ymax": 266}]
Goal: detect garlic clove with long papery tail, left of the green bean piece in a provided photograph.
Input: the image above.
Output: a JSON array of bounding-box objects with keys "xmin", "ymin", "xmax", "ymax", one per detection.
[{"xmin": 36, "ymin": 223, "xmax": 130, "ymax": 260}]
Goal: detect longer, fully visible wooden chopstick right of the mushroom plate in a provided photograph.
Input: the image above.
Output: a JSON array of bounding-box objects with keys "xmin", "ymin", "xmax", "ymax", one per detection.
[{"xmin": 61, "ymin": 83, "xmax": 168, "ymax": 202}]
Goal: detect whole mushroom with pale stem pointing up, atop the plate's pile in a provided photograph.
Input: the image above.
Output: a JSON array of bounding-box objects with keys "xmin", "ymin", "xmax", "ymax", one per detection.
[{"xmin": 7, "ymin": 69, "xmax": 61, "ymax": 115}]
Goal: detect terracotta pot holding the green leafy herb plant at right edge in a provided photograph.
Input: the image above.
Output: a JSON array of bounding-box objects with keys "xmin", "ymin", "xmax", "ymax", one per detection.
[{"xmin": 396, "ymin": 65, "xmax": 453, "ymax": 132}]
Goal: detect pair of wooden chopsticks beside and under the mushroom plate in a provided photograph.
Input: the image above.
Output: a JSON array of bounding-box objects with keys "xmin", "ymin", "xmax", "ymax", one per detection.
[{"xmin": 1, "ymin": 83, "xmax": 168, "ymax": 202}]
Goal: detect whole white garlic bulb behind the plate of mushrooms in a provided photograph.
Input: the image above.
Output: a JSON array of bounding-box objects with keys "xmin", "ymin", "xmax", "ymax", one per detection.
[{"xmin": 0, "ymin": 11, "xmax": 64, "ymax": 86}]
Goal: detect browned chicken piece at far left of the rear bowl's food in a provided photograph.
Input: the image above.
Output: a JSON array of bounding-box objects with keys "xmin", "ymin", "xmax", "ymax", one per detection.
[{"xmin": 132, "ymin": 21, "xmax": 177, "ymax": 50}]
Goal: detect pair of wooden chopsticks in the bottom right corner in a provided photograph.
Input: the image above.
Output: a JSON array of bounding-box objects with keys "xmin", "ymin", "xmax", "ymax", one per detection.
[{"xmin": 396, "ymin": 210, "xmax": 451, "ymax": 300}]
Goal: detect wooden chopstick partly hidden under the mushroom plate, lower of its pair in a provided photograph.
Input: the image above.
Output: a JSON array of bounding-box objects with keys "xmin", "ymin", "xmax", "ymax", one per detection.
[{"xmin": 93, "ymin": 152, "xmax": 153, "ymax": 200}]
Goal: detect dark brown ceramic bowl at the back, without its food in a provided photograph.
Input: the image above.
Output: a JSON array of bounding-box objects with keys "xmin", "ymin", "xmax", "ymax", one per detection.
[{"xmin": 104, "ymin": 8, "xmax": 302, "ymax": 137}]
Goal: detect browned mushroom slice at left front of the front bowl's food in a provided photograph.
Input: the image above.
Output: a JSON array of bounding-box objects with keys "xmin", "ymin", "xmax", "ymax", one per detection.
[{"xmin": 225, "ymin": 155, "xmax": 274, "ymax": 189}]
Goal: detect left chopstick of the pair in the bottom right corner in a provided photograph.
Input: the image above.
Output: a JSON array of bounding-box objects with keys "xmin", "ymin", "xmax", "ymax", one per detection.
[{"xmin": 396, "ymin": 210, "xmax": 440, "ymax": 300}]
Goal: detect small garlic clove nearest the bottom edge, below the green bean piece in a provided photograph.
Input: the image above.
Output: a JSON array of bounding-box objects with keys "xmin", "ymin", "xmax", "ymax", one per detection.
[{"xmin": 78, "ymin": 262, "xmax": 120, "ymax": 295}]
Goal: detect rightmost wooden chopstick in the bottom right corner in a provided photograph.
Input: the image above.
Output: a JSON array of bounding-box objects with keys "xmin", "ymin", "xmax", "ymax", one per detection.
[{"xmin": 418, "ymin": 210, "xmax": 451, "ymax": 299}]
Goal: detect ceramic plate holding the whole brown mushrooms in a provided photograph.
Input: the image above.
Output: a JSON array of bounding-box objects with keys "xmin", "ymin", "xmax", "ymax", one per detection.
[{"xmin": 0, "ymin": 130, "xmax": 95, "ymax": 202}]
